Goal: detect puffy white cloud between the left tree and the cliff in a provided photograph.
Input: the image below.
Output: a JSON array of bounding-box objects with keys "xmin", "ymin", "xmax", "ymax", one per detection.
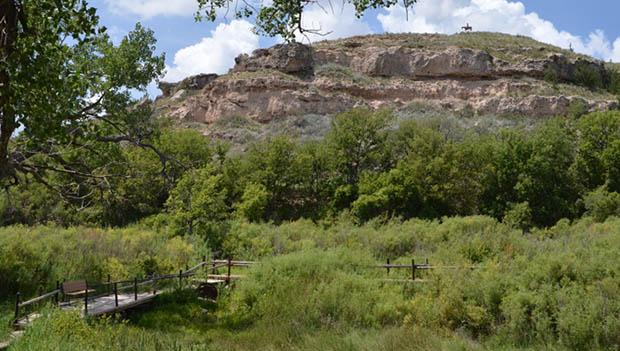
[{"xmin": 164, "ymin": 20, "xmax": 259, "ymax": 81}]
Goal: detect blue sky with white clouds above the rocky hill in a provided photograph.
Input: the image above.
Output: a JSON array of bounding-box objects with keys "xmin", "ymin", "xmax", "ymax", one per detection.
[{"xmin": 90, "ymin": 0, "xmax": 620, "ymax": 94}]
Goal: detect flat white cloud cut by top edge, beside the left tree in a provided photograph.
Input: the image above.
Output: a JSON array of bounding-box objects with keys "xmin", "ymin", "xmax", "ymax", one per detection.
[{"xmin": 105, "ymin": 0, "xmax": 198, "ymax": 19}]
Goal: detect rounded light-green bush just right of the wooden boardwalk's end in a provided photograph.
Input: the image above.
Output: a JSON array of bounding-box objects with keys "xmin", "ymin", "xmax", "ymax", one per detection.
[{"xmin": 228, "ymin": 250, "xmax": 400, "ymax": 337}]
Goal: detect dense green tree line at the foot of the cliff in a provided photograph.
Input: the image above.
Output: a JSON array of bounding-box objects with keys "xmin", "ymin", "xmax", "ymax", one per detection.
[{"xmin": 0, "ymin": 109, "xmax": 620, "ymax": 236}]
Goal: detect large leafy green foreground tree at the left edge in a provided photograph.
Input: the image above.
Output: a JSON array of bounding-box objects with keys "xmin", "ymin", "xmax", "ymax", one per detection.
[{"xmin": 0, "ymin": 0, "xmax": 166, "ymax": 196}]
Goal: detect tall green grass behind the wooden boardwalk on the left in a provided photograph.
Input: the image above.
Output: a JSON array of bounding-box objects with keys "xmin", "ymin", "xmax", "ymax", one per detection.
[{"xmin": 0, "ymin": 226, "xmax": 206, "ymax": 299}]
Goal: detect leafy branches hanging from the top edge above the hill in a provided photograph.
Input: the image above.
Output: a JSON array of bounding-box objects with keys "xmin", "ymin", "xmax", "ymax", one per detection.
[{"xmin": 196, "ymin": 0, "xmax": 417, "ymax": 41}]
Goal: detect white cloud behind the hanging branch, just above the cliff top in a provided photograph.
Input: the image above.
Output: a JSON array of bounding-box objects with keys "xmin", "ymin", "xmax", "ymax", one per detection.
[{"xmin": 297, "ymin": 1, "xmax": 372, "ymax": 42}]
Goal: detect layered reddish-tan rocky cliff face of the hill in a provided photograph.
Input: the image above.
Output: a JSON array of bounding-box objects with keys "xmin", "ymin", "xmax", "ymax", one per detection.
[{"xmin": 155, "ymin": 33, "xmax": 618, "ymax": 140}]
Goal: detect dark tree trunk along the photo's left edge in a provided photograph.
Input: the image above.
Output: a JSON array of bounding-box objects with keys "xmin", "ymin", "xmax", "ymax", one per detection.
[{"xmin": 0, "ymin": 0, "xmax": 18, "ymax": 180}]
